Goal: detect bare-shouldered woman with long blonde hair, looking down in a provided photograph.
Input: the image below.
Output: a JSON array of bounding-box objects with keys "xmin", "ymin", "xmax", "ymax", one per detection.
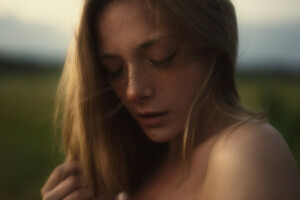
[{"xmin": 42, "ymin": 0, "xmax": 300, "ymax": 200}]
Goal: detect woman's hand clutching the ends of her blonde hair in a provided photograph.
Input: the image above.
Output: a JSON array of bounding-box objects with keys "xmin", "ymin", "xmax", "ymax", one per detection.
[{"xmin": 41, "ymin": 161, "xmax": 93, "ymax": 200}]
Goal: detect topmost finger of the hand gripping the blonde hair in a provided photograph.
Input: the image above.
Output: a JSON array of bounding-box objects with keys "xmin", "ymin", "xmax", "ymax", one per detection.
[{"xmin": 41, "ymin": 161, "xmax": 80, "ymax": 195}]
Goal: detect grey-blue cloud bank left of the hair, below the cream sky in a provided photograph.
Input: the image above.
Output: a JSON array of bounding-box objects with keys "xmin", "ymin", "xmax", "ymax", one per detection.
[{"xmin": 0, "ymin": 16, "xmax": 71, "ymax": 59}]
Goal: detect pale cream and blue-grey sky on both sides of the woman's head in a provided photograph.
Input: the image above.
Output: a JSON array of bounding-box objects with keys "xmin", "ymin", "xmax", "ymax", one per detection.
[{"xmin": 0, "ymin": 0, "xmax": 300, "ymax": 66}]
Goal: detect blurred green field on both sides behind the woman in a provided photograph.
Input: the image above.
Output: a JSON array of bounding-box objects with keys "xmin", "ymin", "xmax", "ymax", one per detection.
[{"xmin": 0, "ymin": 70, "xmax": 300, "ymax": 200}]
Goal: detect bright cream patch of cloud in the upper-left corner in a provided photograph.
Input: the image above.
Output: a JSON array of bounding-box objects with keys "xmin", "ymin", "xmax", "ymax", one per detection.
[{"xmin": 0, "ymin": 0, "xmax": 83, "ymax": 30}]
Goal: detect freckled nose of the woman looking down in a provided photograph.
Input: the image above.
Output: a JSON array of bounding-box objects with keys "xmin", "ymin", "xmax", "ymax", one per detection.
[{"xmin": 126, "ymin": 67, "xmax": 155, "ymax": 103}]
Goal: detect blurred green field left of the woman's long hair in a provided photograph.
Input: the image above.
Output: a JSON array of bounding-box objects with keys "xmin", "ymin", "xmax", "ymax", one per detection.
[{"xmin": 0, "ymin": 70, "xmax": 62, "ymax": 200}]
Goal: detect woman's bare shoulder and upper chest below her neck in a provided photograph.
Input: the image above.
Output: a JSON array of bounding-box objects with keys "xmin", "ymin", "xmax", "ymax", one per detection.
[{"xmin": 129, "ymin": 124, "xmax": 300, "ymax": 200}]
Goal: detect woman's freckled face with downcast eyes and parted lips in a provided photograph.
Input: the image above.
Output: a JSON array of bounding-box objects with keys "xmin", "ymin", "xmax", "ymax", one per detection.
[{"xmin": 97, "ymin": 1, "xmax": 204, "ymax": 142}]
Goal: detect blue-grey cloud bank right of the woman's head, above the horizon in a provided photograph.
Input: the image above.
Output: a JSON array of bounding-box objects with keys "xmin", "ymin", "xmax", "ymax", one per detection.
[{"xmin": 238, "ymin": 24, "xmax": 300, "ymax": 67}]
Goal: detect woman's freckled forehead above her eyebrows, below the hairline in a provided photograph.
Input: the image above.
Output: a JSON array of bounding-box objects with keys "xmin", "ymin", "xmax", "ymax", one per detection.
[{"xmin": 97, "ymin": 0, "xmax": 166, "ymax": 52}]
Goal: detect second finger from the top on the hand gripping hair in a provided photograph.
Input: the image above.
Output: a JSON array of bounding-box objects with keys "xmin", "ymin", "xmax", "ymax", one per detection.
[{"xmin": 44, "ymin": 175, "xmax": 83, "ymax": 199}]
